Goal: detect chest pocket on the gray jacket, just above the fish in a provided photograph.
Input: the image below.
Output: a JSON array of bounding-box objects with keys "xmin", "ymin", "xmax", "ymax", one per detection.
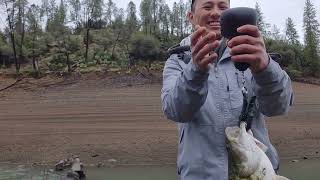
[{"xmin": 226, "ymin": 71, "xmax": 243, "ymax": 109}]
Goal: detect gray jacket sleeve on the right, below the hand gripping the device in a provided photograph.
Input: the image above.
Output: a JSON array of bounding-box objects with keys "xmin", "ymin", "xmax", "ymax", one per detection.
[{"xmin": 253, "ymin": 58, "xmax": 293, "ymax": 117}]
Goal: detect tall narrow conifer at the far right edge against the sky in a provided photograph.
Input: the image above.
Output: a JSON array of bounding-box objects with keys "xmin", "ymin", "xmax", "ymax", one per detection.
[{"xmin": 303, "ymin": 0, "xmax": 320, "ymax": 76}]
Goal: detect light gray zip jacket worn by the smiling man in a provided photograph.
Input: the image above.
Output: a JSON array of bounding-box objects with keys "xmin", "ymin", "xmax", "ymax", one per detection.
[{"xmin": 161, "ymin": 38, "xmax": 293, "ymax": 180}]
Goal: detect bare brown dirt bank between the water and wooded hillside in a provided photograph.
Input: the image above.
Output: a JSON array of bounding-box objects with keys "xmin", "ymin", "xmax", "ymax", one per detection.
[{"xmin": 0, "ymin": 77, "xmax": 320, "ymax": 167}]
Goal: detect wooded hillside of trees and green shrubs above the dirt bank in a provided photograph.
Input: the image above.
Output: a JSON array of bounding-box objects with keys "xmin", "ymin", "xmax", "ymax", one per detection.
[{"xmin": 0, "ymin": 0, "xmax": 320, "ymax": 77}]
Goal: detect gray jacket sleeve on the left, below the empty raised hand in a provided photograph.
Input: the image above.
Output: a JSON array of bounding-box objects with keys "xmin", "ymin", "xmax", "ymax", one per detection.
[{"xmin": 161, "ymin": 55, "xmax": 209, "ymax": 123}]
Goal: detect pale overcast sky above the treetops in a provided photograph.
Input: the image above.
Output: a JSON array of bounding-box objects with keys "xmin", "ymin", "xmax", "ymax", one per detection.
[{"xmin": 0, "ymin": 0, "xmax": 320, "ymax": 39}]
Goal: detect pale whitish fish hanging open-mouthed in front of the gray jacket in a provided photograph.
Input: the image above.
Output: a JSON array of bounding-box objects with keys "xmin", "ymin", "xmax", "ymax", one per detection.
[{"xmin": 225, "ymin": 122, "xmax": 289, "ymax": 180}]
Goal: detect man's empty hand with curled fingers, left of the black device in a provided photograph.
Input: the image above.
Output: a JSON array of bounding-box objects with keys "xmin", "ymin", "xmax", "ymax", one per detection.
[{"xmin": 191, "ymin": 25, "xmax": 219, "ymax": 72}]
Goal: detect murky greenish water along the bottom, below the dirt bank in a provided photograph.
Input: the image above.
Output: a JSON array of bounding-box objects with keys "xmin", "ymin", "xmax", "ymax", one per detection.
[{"xmin": 0, "ymin": 159, "xmax": 320, "ymax": 180}]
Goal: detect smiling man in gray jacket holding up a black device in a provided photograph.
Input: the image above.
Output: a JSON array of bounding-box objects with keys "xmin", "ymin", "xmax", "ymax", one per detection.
[{"xmin": 161, "ymin": 0, "xmax": 292, "ymax": 180}]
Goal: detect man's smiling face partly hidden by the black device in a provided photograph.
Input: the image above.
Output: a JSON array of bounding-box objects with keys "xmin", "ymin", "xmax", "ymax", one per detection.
[{"xmin": 188, "ymin": 0, "xmax": 230, "ymax": 36}]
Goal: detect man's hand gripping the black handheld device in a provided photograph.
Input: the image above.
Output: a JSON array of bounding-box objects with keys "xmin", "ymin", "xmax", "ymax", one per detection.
[{"xmin": 228, "ymin": 25, "xmax": 269, "ymax": 73}]
